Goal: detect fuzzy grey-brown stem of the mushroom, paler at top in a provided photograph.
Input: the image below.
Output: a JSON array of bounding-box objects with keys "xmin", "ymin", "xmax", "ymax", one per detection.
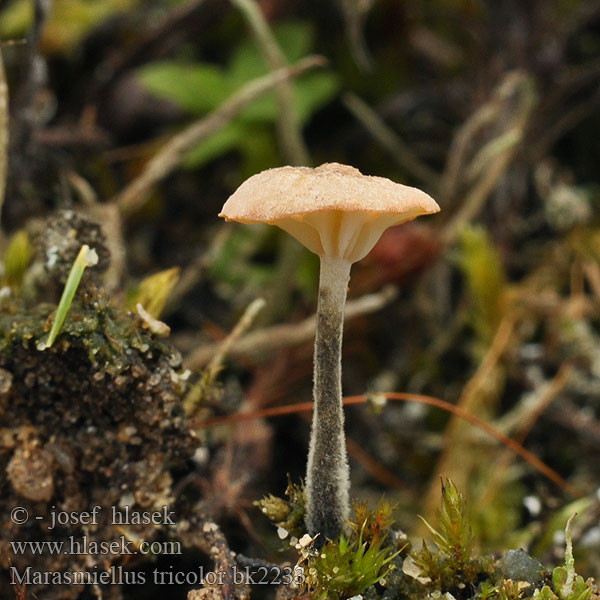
[{"xmin": 306, "ymin": 255, "xmax": 352, "ymax": 543}]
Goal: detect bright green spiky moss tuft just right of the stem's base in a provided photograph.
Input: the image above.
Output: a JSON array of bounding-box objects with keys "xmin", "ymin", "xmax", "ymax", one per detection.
[{"xmin": 307, "ymin": 530, "xmax": 400, "ymax": 600}]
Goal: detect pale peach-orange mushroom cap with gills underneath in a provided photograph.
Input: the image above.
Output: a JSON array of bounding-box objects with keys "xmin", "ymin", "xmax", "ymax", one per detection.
[{"xmin": 219, "ymin": 163, "xmax": 440, "ymax": 262}]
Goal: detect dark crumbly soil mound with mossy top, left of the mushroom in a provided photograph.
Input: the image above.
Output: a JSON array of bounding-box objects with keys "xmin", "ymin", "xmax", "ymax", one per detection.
[{"xmin": 0, "ymin": 240, "xmax": 199, "ymax": 599}]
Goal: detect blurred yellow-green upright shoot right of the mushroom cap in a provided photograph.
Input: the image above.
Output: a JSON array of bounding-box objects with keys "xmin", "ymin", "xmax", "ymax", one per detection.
[{"xmin": 459, "ymin": 226, "xmax": 506, "ymax": 343}]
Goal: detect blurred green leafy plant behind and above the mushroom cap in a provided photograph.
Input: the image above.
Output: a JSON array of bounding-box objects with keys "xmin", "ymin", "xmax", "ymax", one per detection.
[{"xmin": 139, "ymin": 21, "xmax": 339, "ymax": 174}]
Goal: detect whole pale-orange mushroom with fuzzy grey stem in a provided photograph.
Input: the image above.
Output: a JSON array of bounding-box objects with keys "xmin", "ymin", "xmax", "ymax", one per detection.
[{"xmin": 219, "ymin": 163, "xmax": 440, "ymax": 542}]
